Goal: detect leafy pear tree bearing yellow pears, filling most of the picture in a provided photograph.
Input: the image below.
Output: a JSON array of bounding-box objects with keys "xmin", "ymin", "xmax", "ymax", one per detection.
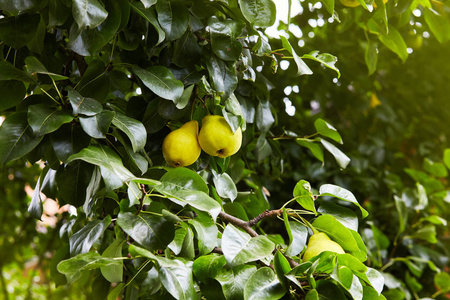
[{"xmin": 0, "ymin": 0, "xmax": 450, "ymax": 300}]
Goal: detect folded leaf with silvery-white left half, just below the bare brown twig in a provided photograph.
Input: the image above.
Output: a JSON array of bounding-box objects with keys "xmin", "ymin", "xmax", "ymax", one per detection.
[{"xmin": 222, "ymin": 224, "xmax": 275, "ymax": 266}]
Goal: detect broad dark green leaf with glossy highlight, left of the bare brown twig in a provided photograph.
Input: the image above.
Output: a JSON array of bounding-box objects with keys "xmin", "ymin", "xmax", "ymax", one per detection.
[{"xmin": 117, "ymin": 212, "xmax": 175, "ymax": 251}]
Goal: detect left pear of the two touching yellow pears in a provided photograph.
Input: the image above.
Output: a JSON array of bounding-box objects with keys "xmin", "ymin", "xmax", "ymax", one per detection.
[{"xmin": 162, "ymin": 121, "xmax": 202, "ymax": 167}]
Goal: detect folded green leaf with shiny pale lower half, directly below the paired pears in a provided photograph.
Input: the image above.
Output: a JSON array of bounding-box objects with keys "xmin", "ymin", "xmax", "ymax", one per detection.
[{"xmin": 155, "ymin": 168, "xmax": 222, "ymax": 219}]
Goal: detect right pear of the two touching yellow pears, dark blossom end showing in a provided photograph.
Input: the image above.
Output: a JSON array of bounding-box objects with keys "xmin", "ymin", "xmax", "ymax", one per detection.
[{"xmin": 198, "ymin": 115, "xmax": 242, "ymax": 158}]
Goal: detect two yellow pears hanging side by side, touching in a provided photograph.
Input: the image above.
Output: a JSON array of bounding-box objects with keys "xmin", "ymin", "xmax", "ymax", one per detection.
[{"xmin": 162, "ymin": 115, "xmax": 242, "ymax": 167}]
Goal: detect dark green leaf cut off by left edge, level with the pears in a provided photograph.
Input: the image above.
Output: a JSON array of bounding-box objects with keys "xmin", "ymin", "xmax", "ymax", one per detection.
[{"xmin": 0, "ymin": 113, "xmax": 43, "ymax": 166}]
